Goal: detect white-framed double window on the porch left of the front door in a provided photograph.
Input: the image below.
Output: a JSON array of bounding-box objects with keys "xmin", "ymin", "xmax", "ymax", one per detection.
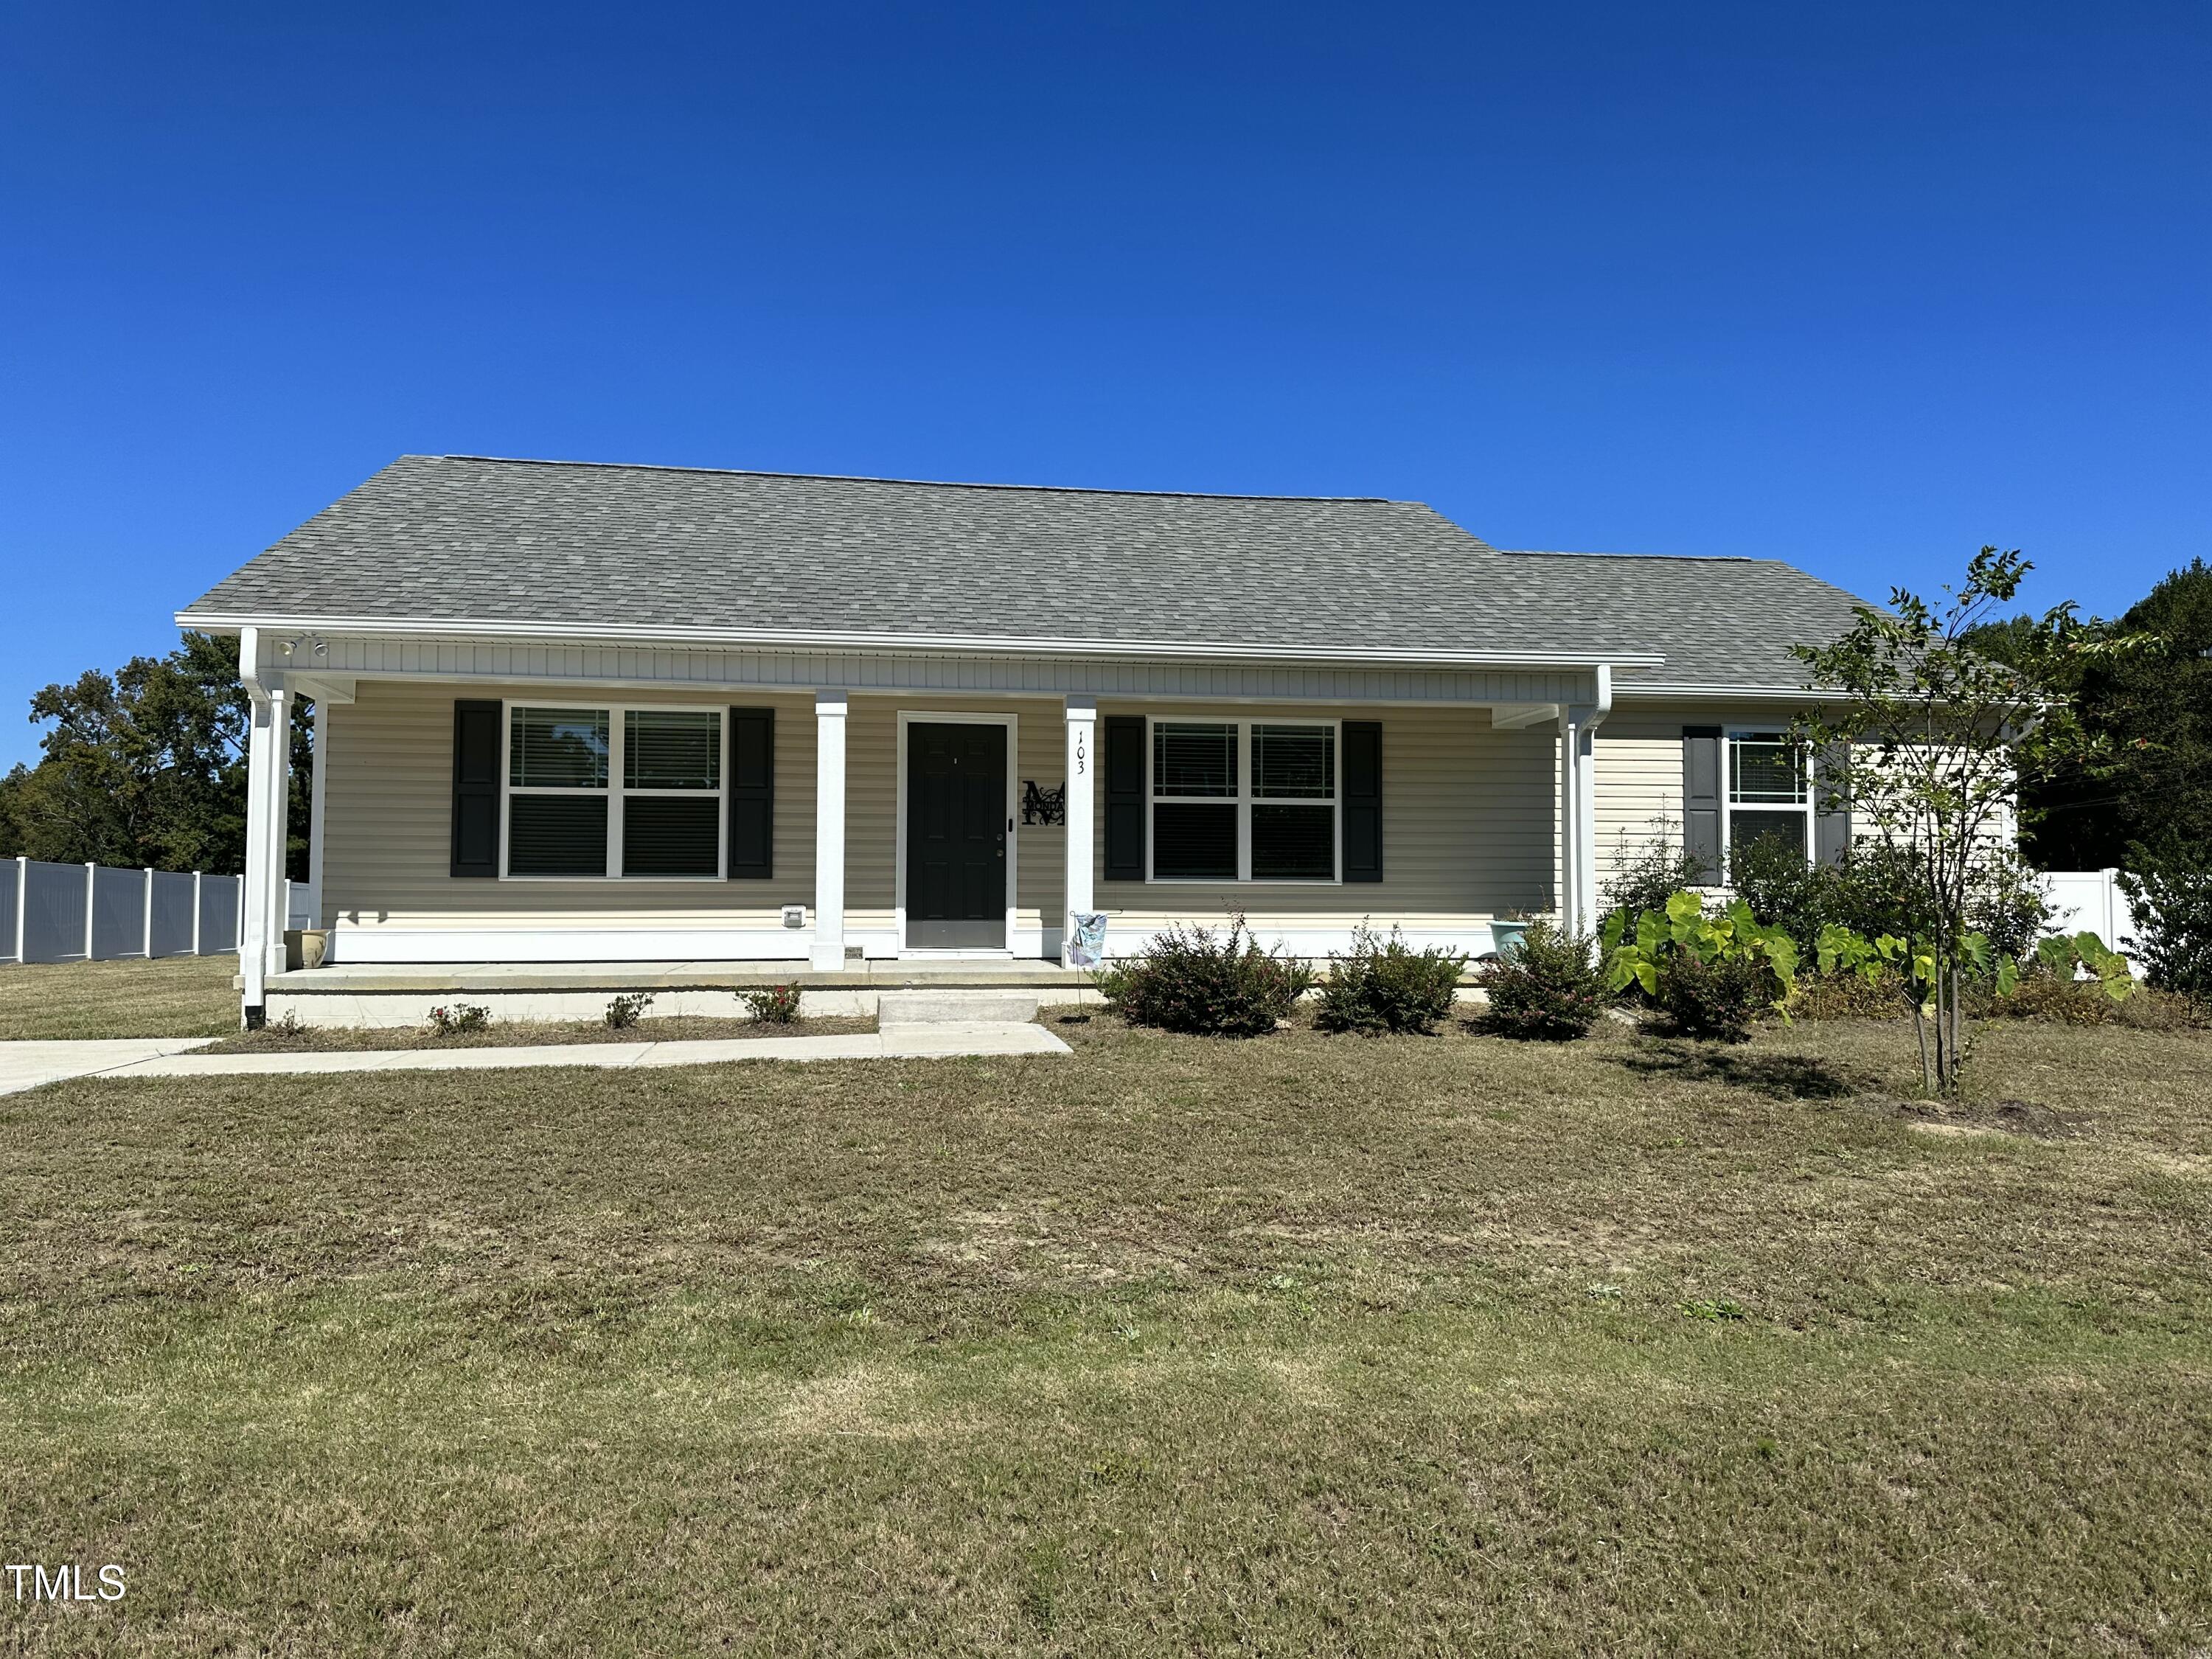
[{"xmin": 500, "ymin": 703, "xmax": 728, "ymax": 880}]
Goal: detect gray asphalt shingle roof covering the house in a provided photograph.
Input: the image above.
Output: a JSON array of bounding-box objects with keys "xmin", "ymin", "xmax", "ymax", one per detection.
[{"xmin": 179, "ymin": 456, "xmax": 1851, "ymax": 686}]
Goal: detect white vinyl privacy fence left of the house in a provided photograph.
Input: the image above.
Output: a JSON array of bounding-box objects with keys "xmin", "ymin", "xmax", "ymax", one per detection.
[{"xmin": 0, "ymin": 858, "xmax": 316, "ymax": 962}]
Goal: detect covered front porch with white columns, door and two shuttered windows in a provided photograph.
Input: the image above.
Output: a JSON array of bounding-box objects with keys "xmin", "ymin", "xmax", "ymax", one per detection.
[{"xmin": 239, "ymin": 628, "xmax": 1646, "ymax": 1022}]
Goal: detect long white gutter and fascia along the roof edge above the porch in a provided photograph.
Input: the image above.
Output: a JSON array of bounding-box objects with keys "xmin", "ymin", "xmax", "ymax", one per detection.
[{"xmin": 175, "ymin": 611, "xmax": 1666, "ymax": 668}]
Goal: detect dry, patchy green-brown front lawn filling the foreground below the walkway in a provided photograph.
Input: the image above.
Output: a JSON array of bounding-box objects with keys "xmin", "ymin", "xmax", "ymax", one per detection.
[{"xmin": 0, "ymin": 1020, "xmax": 2212, "ymax": 1655}]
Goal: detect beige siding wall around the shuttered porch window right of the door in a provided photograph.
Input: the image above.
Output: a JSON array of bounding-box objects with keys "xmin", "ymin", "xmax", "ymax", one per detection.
[{"xmin": 1093, "ymin": 703, "xmax": 1559, "ymax": 936}]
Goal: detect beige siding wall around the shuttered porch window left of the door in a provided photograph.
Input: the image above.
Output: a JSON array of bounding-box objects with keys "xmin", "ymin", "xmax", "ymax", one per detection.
[{"xmin": 323, "ymin": 679, "xmax": 814, "ymax": 929}]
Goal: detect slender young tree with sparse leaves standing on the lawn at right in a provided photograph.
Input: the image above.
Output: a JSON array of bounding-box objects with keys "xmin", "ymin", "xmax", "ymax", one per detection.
[{"xmin": 1794, "ymin": 546, "xmax": 2141, "ymax": 1095}]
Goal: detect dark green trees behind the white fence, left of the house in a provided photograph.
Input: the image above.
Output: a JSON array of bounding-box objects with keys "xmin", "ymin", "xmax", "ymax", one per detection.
[{"xmin": 0, "ymin": 633, "xmax": 314, "ymax": 880}]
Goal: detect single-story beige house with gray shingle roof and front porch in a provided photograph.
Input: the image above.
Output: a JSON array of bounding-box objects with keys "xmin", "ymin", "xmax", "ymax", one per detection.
[{"xmin": 177, "ymin": 456, "xmax": 1856, "ymax": 1018}]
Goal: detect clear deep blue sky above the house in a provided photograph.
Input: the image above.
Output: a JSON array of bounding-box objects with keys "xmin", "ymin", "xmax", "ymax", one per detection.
[{"xmin": 0, "ymin": 0, "xmax": 2212, "ymax": 763}]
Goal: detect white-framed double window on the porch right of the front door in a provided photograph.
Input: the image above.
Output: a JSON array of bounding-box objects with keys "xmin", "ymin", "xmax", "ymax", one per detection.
[{"xmin": 1146, "ymin": 717, "xmax": 1343, "ymax": 883}]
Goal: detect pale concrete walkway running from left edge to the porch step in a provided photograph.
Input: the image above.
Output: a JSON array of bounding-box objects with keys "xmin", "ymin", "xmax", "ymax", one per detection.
[{"xmin": 0, "ymin": 1020, "xmax": 1071, "ymax": 1095}]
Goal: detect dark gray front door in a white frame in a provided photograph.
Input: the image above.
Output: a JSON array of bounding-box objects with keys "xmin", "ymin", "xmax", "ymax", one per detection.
[{"xmin": 907, "ymin": 721, "xmax": 1006, "ymax": 951}]
